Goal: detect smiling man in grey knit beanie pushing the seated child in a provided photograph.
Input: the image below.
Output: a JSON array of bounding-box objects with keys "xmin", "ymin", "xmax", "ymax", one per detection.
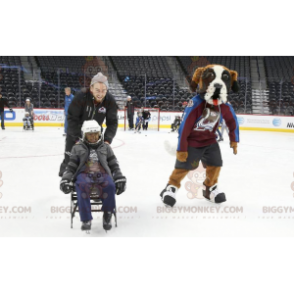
[{"xmin": 59, "ymin": 73, "xmax": 118, "ymax": 177}]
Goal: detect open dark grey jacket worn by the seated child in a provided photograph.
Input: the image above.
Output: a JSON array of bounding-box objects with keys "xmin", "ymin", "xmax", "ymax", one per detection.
[{"xmin": 62, "ymin": 140, "xmax": 123, "ymax": 182}]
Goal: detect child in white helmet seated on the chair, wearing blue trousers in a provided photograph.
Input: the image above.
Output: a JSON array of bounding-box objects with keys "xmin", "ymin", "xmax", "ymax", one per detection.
[{"xmin": 60, "ymin": 120, "xmax": 127, "ymax": 231}]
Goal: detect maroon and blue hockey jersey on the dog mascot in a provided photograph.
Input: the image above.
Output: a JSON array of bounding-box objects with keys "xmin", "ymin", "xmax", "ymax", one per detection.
[{"xmin": 177, "ymin": 94, "xmax": 239, "ymax": 152}]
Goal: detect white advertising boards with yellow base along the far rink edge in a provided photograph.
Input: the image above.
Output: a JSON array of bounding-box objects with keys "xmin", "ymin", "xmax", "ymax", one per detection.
[{"xmin": 4, "ymin": 109, "xmax": 294, "ymax": 133}]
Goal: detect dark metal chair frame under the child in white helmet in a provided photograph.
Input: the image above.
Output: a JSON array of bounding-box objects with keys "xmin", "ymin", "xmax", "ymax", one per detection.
[{"xmin": 70, "ymin": 189, "xmax": 117, "ymax": 229}]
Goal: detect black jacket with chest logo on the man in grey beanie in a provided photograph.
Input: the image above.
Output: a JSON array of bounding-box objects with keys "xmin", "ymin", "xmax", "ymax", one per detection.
[{"xmin": 67, "ymin": 91, "xmax": 118, "ymax": 144}]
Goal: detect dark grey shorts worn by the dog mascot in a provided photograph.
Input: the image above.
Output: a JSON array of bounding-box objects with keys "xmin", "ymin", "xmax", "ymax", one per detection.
[{"xmin": 176, "ymin": 143, "xmax": 223, "ymax": 170}]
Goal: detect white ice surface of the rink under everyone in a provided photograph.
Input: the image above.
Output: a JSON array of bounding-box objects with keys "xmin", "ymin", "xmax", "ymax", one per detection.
[{"xmin": 0, "ymin": 127, "xmax": 294, "ymax": 238}]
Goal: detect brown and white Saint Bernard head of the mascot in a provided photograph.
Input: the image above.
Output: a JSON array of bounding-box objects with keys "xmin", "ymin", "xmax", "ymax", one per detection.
[{"xmin": 191, "ymin": 65, "xmax": 239, "ymax": 106}]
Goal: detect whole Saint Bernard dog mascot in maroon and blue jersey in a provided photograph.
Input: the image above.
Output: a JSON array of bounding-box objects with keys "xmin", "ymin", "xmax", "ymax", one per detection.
[{"xmin": 160, "ymin": 65, "xmax": 239, "ymax": 207}]
